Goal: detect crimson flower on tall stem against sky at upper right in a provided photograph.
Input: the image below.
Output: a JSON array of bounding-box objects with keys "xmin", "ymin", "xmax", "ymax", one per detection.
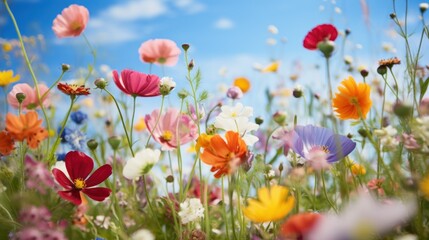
[{"xmin": 304, "ymin": 24, "xmax": 338, "ymax": 50}]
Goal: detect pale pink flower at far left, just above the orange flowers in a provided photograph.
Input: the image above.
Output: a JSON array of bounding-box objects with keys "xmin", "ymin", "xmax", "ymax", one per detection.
[{"xmin": 7, "ymin": 83, "xmax": 49, "ymax": 109}]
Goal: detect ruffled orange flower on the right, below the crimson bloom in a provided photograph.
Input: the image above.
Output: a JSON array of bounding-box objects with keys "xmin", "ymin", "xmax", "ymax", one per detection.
[{"xmin": 332, "ymin": 76, "xmax": 372, "ymax": 120}]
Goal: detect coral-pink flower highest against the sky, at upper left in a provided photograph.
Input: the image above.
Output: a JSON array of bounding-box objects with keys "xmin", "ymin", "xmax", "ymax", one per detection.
[{"xmin": 52, "ymin": 4, "xmax": 89, "ymax": 38}]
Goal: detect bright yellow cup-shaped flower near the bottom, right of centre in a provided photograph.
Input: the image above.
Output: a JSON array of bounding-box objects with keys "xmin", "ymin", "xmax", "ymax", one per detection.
[{"xmin": 243, "ymin": 186, "xmax": 295, "ymax": 223}]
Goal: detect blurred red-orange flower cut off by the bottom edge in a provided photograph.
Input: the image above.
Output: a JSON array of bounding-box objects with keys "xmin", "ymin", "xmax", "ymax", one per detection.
[{"xmin": 280, "ymin": 213, "xmax": 322, "ymax": 240}]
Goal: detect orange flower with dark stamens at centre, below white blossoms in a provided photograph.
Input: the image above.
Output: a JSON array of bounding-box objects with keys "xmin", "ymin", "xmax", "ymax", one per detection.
[{"xmin": 201, "ymin": 131, "xmax": 247, "ymax": 178}]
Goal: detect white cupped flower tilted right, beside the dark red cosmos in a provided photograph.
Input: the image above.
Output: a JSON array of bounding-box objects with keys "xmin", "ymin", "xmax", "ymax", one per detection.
[{"xmin": 122, "ymin": 148, "xmax": 161, "ymax": 180}]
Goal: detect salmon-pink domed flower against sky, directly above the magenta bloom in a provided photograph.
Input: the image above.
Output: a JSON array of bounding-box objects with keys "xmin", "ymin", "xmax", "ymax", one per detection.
[{"xmin": 139, "ymin": 39, "xmax": 180, "ymax": 66}]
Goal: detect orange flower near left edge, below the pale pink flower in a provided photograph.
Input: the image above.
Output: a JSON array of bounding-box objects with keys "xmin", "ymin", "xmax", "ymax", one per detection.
[{"xmin": 6, "ymin": 111, "xmax": 48, "ymax": 148}]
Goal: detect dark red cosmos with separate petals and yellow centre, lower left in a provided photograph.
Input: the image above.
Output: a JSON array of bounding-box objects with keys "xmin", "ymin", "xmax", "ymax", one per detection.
[{"xmin": 52, "ymin": 151, "xmax": 112, "ymax": 205}]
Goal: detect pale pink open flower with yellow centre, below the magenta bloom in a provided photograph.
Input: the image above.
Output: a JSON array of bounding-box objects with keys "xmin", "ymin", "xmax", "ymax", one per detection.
[{"xmin": 145, "ymin": 108, "xmax": 197, "ymax": 150}]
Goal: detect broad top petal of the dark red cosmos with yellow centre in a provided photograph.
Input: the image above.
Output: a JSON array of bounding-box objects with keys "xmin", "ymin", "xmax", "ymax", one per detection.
[{"xmin": 65, "ymin": 151, "xmax": 94, "ymax": 181}]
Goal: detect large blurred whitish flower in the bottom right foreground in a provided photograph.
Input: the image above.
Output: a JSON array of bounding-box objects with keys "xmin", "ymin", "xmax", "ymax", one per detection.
[{"xmin": 308, "ymin": 193, "xmax": 416, "ymax": 240}]
